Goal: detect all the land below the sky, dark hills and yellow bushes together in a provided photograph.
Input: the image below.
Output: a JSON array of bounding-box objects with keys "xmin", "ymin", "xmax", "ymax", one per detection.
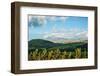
[{"xmin": 28, "ymin": 39, "xmax": 88, "ymax": 60}]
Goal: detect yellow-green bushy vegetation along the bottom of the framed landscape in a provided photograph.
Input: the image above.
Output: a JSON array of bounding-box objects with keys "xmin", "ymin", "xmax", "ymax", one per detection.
[{"xmin": 28, "ymin": 48, "xmax": 88, "ymax": 60}]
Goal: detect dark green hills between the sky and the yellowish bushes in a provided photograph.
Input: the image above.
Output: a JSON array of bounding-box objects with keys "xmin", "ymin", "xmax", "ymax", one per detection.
[{"xmin": 28, "ymin": 39, "xmax": 88, "ymax": 49}]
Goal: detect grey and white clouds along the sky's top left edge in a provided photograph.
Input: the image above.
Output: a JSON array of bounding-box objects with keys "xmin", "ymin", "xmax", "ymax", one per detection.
[{"xmin": 28, "ymin": 15, "xmax": 68, "ymax": 27}]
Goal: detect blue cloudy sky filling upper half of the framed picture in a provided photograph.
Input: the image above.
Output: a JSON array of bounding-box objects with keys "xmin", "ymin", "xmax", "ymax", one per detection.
[{"xmin": 28, "ymin": 15, "xmax": 88, "ymax": 41}]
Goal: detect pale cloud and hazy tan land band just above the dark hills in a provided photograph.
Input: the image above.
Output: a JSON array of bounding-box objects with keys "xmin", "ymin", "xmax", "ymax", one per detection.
[{"xmin": 43, "ymin": 31, "xmax": 88, "ymax": 43}]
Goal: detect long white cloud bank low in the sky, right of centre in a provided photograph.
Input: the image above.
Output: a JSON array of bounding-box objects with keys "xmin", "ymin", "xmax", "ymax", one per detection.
[{"xmin": 44, "ymin": 31, "xmax": 87, "ymax": 39}]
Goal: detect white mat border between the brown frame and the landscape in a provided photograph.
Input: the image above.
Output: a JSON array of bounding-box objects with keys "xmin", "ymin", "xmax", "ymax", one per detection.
[{"xmin": 20, "ymin": 7, "xmax": 94, "ymax": 70}]
